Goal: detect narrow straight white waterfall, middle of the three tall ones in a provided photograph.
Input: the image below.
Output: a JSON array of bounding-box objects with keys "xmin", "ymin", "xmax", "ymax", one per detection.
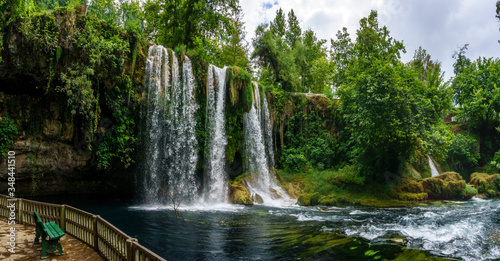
[{"xmin": 204, "ymin": 65, "xmax": 227, "ymax": 203}]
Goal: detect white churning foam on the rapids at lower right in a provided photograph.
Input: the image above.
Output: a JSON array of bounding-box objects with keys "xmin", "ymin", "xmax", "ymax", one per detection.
[{"xmin": 344, "ymin": 199, "xmax": 500, "ymax": 260}]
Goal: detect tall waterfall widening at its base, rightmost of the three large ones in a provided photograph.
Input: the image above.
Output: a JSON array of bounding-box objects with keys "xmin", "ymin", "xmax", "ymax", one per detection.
[{"xmin": 243, "ymin": 82, "xmax": 288, "ymax": 204}]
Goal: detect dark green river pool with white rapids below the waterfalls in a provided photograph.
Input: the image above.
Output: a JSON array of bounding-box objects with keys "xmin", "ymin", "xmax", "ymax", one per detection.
[{"xmin": 36, "ymin": 197, "xmax": 500, "ymax": 260}]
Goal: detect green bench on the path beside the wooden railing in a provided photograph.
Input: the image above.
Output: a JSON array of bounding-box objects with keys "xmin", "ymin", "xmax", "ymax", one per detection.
[{"xmin": 33, "ymin": 211, "xmax": 64, "ymax": 259}]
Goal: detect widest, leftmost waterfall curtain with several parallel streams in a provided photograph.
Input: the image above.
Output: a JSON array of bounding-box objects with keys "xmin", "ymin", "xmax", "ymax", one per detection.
[{"xmin": 142, "ymin": 46, "xmax": 198, "ymax": 203}]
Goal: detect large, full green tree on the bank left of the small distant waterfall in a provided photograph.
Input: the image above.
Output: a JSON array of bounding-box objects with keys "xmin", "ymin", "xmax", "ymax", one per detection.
[{"xmin": 339, "ymin": 11, "xmax": 448, "ymax": 180}]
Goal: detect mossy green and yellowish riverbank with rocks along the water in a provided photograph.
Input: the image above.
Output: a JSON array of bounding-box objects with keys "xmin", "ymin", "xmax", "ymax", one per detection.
[{"xmin": 277, "ymin": 166, "xmax": 494, "ymax": 207}]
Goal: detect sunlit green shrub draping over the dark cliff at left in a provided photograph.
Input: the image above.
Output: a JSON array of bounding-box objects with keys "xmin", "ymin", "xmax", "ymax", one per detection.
[{"xmin": 56, "ymin": 14, "xmax": 129, "ymax": 129}]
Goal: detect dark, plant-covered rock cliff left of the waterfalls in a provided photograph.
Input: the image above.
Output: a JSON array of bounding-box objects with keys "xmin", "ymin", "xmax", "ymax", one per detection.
[{"xmin": 0, "ymin": 8, "xmax": 147, "ymax": 195}]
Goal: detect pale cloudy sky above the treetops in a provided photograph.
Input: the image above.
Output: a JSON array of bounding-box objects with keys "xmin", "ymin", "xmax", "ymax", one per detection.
[{"xmin": 240, "ymin": 0, "xmax": 500, "ymax": 79}]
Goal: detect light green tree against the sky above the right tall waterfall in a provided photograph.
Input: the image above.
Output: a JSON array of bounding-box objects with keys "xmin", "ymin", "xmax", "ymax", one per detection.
[{"xmin": 252, "ymin": 9, "xmax": 333, "ymax": 93}]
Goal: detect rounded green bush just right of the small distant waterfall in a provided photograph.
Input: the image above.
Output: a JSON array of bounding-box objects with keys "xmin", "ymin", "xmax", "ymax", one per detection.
[{"xmin": 446, "ymin": 134, "xmax": 481, "ymax": 175}]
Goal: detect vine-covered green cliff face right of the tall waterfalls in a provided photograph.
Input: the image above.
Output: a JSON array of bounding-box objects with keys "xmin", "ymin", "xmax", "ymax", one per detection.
[{"xmin": 266, "ymin": 89, "xmax": 342, "ymax": 172}]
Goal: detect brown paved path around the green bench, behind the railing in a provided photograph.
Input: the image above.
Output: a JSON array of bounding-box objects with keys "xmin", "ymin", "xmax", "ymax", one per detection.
[{"xmin": 0, "ymin": 219, "xmax": 103, "ymax": 261}]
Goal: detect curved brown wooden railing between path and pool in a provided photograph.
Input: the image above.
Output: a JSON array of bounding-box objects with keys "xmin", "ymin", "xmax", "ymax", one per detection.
[{"xmin": 0, "ymin": 194, "xmax": 166, "ymax": 261}]
